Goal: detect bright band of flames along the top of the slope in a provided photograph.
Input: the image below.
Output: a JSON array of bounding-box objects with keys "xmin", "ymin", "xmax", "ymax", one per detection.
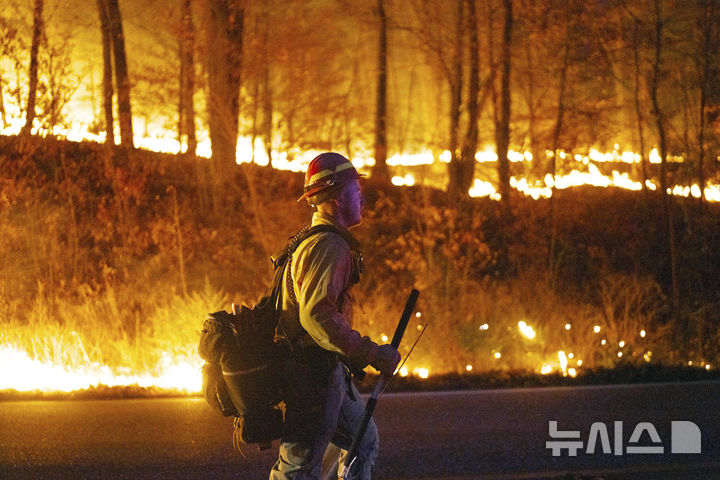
[{"xmin": 0, "ymin": 106, "xmax": 720, "ymax": 202}]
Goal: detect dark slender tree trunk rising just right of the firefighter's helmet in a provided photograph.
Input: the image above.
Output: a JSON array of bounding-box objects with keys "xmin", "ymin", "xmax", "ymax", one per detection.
[{"xmin": 372, "ymin": 0, "xmax": 390, "ymax": 182}]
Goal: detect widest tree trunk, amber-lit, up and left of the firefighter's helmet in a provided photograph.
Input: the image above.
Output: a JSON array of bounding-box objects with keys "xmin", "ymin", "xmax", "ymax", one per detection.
[{"xmin": 206, "ymin": 0, "xmax": 245, "ymax": 182}]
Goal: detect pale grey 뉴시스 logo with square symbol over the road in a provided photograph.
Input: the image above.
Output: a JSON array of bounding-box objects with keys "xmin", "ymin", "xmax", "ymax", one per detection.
[{"xmin": 545, "ymin": 420, "xmax": 702, "ymax": 457}]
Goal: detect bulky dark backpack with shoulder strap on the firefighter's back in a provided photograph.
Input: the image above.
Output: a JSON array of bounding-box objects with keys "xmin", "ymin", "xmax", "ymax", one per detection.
[{"xmin": 198, "ymin": 225, "xmax": 340, "ymax": 450}]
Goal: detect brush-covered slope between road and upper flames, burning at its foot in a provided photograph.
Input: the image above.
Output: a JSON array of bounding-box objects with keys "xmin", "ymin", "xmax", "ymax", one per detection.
[{"xmin": 0, "ymin": 138, "xmax": 720, "ymax": 395}]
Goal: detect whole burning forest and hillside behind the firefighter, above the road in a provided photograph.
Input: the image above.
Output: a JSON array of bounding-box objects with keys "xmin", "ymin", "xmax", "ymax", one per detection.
[{"xmin": 0, "ymin": 0, "xmax": 720, "ymax": 394}]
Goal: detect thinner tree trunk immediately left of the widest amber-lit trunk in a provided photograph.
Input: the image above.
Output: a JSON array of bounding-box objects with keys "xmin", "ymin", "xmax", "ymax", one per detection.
[{"xmin": 178, "ymin": 0, "xmax": 197, "ymax": 155}]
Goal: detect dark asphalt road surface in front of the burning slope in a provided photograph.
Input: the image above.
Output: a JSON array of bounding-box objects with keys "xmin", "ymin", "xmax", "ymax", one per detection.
[{"xmin": 0, "ymin": 382, "xmax": 720, "ymax": 480}]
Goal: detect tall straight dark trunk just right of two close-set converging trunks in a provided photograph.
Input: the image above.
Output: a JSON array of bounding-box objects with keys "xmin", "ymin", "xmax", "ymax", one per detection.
[{"xmin": 495, "ymin": 0, "xmax": 513, "ymax": 214}]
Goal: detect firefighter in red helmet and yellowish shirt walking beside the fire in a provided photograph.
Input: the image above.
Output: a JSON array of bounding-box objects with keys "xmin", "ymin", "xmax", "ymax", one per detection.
[{"xmin": 270, "ymin": 152, "xmax": 400, "ymax": 480}]
